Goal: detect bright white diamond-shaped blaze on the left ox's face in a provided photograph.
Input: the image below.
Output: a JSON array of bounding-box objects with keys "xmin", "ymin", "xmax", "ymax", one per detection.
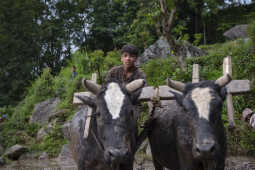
[{"xmin": 104, "ymin": 83, "xmax": 125, "ymax": 119}]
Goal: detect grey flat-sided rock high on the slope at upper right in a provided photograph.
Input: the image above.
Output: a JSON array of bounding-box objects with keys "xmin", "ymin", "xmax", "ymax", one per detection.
[{"xmin": 223, "ymin": 25, "xmax": 248, "ymax": 40}]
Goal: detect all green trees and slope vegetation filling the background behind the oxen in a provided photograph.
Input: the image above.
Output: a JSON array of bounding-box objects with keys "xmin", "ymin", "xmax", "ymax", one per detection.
[{"xmin": 0, "ymin": 0, "xmax": 255, "ymax": 160}]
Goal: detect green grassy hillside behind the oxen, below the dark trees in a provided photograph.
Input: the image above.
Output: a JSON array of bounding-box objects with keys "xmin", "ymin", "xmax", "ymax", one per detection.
[{"xmin": 0, "ymin": 39, "xmax": 255, "ymax": 166}]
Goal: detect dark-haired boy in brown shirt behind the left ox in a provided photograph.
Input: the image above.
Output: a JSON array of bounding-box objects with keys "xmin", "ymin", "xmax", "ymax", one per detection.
[{"xmin": 105, "ymin": 45, "xmax": 146, "ymax": 84}]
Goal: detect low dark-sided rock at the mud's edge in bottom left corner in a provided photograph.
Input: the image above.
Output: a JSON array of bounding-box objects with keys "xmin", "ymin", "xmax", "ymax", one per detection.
[{"xmin": 4, "ymin": 144, "xmax": 28, "ymax": 160}]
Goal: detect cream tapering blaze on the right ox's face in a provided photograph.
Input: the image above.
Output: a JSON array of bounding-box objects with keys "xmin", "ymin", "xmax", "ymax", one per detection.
[{"xmin": 191, "ymin": 88, "xmax": 213, "ymax": 121}]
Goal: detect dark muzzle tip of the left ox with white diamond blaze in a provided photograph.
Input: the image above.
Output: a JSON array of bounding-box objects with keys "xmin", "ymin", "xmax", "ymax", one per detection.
[{"xmin": 104, "ymin": 148, "xmax": 129, "ymax": 164}]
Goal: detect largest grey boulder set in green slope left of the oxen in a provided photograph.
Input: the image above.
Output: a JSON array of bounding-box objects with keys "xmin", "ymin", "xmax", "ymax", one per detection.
[{"xmin": 30, "ymin": 98, "xmax": 60, "ymax": 125}]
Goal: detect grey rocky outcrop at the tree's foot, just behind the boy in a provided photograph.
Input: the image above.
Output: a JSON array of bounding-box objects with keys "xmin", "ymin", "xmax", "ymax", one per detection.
[{"xmin": 136, "ymin": 37, "xmax": 205, "ymax": 66}]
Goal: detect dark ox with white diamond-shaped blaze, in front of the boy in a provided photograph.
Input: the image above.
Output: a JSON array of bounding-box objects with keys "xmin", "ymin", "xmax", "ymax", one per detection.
[{"xmin": 71, "ymin": 79, "xmax": 144, "ymax": 170}]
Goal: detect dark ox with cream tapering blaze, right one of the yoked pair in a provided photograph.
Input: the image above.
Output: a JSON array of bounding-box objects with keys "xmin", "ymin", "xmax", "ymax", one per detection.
[{"xmin": 149, "ymin": 75, "xmax": 231, "ymax": 170}]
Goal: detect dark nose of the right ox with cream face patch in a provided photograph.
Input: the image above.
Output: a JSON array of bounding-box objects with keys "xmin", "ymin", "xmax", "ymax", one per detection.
[{"xmin": 195, "ymin": 141, "xmax": 216, "ymax": 158}]
